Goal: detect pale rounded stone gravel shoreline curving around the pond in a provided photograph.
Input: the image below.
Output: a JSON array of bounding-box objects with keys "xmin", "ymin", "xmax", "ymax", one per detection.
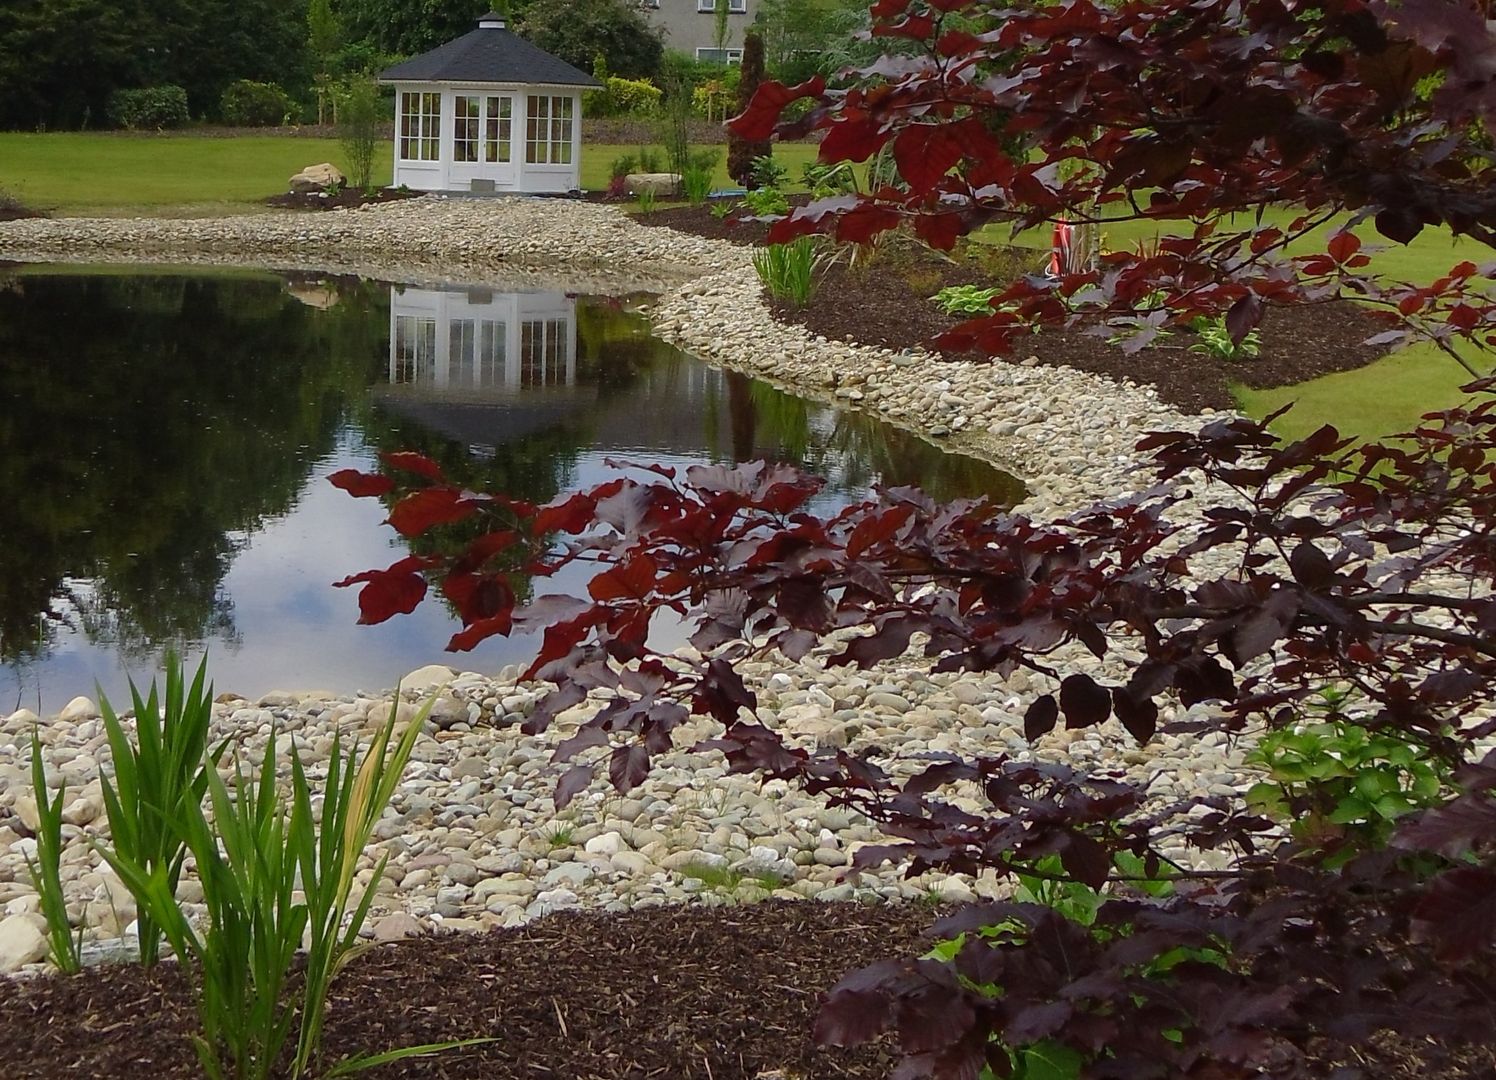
[{"xmin": 0, "ymin": 199, "xmax": 1252, "ymax": 971}]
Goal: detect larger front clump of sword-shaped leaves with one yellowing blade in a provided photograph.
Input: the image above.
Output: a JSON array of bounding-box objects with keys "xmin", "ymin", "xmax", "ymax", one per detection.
[{"xmin": 102, "ymin": 682, "xmax": 472, "ymax": 1080}]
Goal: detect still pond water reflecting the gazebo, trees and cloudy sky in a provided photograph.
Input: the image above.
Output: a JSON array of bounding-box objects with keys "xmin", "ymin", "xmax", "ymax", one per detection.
[{"xmin": 0, "ymin": 266, "xmax": 1020, "ymax": 715}]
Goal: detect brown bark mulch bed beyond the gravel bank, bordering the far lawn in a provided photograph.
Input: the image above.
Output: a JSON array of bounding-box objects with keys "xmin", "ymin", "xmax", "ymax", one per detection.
[{"xmin": 646, "ymin": 206, "xmax": 1388, "ymax": 411}]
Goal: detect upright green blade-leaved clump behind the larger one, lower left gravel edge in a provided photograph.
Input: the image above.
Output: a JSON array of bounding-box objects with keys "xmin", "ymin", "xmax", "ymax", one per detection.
[{"xmin": 99, "ymin": 654, "xmax": 224, "ymax": 966}]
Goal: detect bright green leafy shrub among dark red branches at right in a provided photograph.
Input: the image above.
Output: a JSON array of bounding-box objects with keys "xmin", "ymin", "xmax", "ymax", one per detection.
[{"xmin": 1246, "ymin": 690, "xmax": 1451, "ymax": 868}]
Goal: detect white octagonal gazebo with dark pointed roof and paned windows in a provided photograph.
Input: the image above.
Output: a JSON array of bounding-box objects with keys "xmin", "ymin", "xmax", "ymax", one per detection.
[{"xmin": 380, "ymin": 12, "xmax": 600, "ymax": 194}]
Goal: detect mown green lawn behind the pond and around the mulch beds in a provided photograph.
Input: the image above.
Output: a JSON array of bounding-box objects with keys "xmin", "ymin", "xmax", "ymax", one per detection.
[{"xmin": 0, "ymin": 133, "xmax": 1484, "ymax": 437}]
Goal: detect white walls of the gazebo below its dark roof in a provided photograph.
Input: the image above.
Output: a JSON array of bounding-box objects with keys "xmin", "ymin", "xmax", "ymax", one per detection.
[{"xmin": 393, "ymin": 82, "xmax": 582, "ymax": 194}]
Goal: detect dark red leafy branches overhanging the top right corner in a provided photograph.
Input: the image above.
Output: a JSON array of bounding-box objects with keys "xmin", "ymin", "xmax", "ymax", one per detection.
[{"xmin": 733, "ymin": 0, "xmax": 1496, "ymax": 366}]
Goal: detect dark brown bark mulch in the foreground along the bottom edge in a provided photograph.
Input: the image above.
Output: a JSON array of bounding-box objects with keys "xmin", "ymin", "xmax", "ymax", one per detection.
[{"xmin": 0, "ymin": 902, "xmax": 1496, "ymax": 1080}]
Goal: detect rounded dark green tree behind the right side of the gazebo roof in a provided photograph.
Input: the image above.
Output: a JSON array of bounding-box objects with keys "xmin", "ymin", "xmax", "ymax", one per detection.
[{"xmin": 518, "ymin": 0, "xmax": 664, "ymax": 79}]
